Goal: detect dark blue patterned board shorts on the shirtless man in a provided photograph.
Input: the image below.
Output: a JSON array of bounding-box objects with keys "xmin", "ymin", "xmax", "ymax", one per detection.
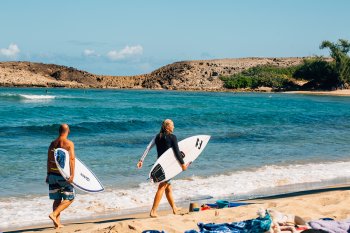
[{"xmin": 48, "ymin": 173, "xmax": 75, "ymax": 200}]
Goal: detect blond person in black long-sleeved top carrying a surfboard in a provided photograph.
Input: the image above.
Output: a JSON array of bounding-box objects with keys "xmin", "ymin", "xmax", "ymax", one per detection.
[{"xmin": 137, "ymin": 119, "xmax": 187, "ymax": 218}]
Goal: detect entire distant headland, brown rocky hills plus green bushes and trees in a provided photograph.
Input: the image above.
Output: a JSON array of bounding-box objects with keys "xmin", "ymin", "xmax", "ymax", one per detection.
[{"xmin": 0, "ymin": 39, "xmax": 350, "ymax": 91}]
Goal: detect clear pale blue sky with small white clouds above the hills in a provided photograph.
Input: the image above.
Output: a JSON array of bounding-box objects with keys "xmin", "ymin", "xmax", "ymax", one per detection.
[{"xmin": 0, "ymin": 0, "xmax": 350, "ymax": 75}]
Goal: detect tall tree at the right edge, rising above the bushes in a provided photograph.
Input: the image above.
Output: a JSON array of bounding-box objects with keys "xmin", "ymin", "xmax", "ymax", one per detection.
[{"xmin": 320, "ymin": 39, "xmax": 350, "ymax": 88}]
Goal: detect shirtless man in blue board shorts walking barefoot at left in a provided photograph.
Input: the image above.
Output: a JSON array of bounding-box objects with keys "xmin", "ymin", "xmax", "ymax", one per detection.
[{"xmin": 46, "ymin": 124, "xmax": 75, "ymax": 228}]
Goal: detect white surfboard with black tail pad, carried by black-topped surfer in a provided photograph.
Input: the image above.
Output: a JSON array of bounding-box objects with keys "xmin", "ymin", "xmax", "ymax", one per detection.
[{"xmin": 148, "ymin": 135, "xmax": 210, "ymax": 183}]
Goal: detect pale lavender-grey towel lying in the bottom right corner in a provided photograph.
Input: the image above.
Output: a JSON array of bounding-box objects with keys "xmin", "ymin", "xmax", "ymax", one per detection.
[{"xmin": 309, "ymin": 219, "xmax": 350, "ymax": 233}]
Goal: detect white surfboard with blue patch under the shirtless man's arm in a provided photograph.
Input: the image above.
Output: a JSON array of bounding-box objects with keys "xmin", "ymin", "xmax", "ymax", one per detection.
[{"xmin": 54, "ymin": 148, "xmax": 104, "ymax": 192}]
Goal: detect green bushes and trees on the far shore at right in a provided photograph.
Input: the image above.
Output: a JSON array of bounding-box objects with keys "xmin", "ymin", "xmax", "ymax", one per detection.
[{"xmin": 220, "ymin": 39, "xmax": 350, "ymax": 90}]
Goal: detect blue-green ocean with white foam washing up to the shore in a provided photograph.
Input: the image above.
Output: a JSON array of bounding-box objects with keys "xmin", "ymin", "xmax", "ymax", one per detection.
[{"xmin": 0, "ymin": 88, "xmax": 350, "ymax": 230}]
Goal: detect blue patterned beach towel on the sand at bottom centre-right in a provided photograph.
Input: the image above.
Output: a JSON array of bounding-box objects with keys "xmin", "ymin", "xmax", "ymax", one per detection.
[{"xmin": 185, "ymin": 214, "xmax": 272, "ymax": 233}]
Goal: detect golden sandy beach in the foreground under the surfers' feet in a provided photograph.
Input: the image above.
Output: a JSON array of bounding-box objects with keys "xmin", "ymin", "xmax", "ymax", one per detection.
[{"xmin": 6, "ymin": 186, "xmax": 350, "ymax": 233}]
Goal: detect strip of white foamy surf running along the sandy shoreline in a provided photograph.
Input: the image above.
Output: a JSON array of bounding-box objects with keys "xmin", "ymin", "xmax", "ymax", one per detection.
[{"xmin": 0, "ymin": 162, "xmax": 350, "ymax": 230}]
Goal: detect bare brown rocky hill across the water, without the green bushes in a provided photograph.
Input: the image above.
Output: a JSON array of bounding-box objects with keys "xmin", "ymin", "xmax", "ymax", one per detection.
[{"xmin": 0, "ymin": 57, "xmax": 303, "ymax": 91}]
